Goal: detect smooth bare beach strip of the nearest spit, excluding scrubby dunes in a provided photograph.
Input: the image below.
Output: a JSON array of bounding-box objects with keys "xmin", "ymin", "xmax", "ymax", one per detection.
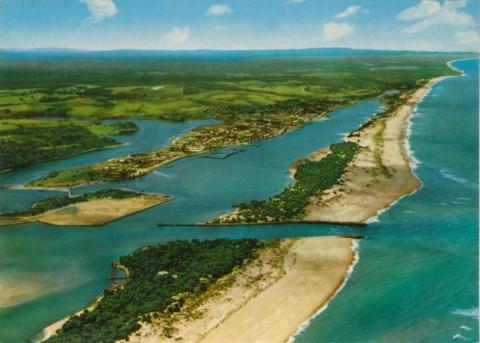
[{"xmin": 200, "ymin": 236, "xmax": 357, "ymax": 343}]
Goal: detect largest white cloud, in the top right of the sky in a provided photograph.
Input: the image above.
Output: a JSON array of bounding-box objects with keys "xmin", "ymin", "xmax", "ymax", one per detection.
[{"xmin": 397, "ymin": 0, "xmax": 474, "ymax": 33}]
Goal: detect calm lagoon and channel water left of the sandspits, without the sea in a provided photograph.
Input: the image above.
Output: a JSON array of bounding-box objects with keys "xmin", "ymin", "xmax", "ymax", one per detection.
[{"xmin": 0, "ymin": 100, "xmax": 379, "ymax": 343}]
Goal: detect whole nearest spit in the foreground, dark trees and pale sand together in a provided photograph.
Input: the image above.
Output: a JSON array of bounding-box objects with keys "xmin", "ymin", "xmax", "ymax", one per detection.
[{"xmin": 40, "ymin": 236, "xmax": 356, "ymax": 343}]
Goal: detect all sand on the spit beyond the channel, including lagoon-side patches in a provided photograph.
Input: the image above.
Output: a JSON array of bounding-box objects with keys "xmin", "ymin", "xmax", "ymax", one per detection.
[{"xmin": 202, "ymin": 76, "xmax": 448, "ymax": 226}]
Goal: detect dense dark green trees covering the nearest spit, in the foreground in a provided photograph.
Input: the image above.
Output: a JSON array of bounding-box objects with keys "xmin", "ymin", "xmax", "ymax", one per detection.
[{"xmin": 46, "ymin": 239, "xmax": 264, "ymax": 343}]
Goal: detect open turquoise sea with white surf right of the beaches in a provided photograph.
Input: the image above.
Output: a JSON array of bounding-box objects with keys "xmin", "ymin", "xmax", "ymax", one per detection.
[{"xmin": 296, "ymin": 60, "xmax": 479, "ymax": 343}]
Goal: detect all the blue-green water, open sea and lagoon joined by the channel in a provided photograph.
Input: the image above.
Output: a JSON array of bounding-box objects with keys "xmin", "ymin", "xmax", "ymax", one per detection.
[{"xmin": 0, "ymin": 61, "xmax": 478, "ymax": 343}]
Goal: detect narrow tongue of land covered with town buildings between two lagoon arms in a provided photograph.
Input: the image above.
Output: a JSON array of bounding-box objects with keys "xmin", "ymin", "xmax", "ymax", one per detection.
[{"xmin": 27, "ymin": 100, "xmax": 339, "ymax": 188}]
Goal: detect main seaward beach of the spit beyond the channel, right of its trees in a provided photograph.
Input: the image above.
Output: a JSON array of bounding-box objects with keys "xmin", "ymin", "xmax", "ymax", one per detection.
[{"xmin": 305, "ymin": 78, "xmax": 442, "ymax": 224}]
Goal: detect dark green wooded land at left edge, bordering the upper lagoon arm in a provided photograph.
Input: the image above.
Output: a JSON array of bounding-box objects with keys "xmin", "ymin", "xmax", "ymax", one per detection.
[{"xmin": 0, "ymin": 119, "xmax": 138, "ymax": 172}]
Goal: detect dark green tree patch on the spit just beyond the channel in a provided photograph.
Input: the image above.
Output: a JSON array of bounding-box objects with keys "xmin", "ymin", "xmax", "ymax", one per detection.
[{"xmin": 208, "ymin": 142, "xmax": 359, "ymax": 224}]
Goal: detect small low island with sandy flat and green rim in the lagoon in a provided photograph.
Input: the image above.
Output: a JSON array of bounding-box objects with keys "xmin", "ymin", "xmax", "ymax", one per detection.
[{"xmin": 0, "ymin": 189, "xmax": 171, "ymax": 226}]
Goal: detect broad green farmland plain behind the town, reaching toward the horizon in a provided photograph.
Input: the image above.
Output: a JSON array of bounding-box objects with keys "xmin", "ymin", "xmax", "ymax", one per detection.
[{"xmin": 0, "ymin": 54, "xmax": 460, "ymax": 121}]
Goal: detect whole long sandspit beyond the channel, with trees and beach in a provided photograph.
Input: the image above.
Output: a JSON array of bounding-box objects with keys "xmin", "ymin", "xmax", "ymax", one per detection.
[{"xmin": 206, "ymin": 77, "xmax": 448, "ymax": 225}]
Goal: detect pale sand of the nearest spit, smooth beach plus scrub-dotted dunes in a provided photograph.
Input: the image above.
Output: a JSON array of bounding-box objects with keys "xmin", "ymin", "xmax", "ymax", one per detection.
[{"xmin": 121, "ymin": 236, "xmax": 355, "ymax": 343}]
